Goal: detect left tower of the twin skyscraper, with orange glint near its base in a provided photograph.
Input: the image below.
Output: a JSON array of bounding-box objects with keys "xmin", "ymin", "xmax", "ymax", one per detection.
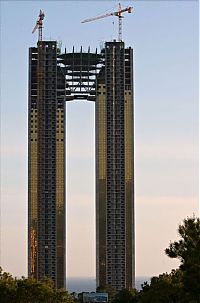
[{"xmin": 28, "ymin": 41, "xmax": 66, "ymax": 288}]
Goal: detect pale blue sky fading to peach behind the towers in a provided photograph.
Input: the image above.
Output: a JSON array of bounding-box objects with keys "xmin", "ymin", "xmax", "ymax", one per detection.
[{"xmin": 0, "ymin": 0, "xmax": 199, "ymax": 276}]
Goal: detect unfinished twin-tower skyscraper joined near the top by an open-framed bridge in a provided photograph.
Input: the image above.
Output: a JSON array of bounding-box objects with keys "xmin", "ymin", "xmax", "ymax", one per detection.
[{"xmin": 28, "ymin": 41, "xmax": 135, "ymax": 290}]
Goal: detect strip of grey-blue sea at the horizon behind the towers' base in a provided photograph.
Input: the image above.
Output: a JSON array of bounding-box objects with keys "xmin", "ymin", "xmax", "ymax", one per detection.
[{"xmin": 66, "ymin": 277, "xmax": 150, "ymax": 293}]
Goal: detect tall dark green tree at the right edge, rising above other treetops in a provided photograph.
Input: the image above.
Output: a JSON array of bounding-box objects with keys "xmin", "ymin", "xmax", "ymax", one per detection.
[{"xmin": 165, "ymin": 217, "xmax": 200, "ymax": 302}]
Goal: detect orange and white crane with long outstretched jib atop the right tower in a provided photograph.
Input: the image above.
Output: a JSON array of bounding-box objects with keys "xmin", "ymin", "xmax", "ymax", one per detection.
[{"xmin": 81, "ymin": 3, "xmax": 133, "ymax": 41}]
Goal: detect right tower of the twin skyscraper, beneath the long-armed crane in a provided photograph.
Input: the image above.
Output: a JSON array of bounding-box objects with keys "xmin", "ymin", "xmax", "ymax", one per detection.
[{"xmin": 96, "ymin": 42, "xmax": 135, "ymax": 290}]
